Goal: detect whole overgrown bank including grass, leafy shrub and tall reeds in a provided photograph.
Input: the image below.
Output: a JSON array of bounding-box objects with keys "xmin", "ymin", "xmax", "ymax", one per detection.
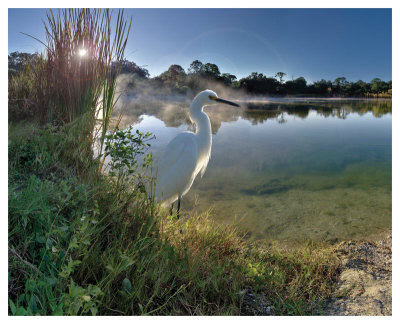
[{"xmin": 8, "ymin": 9, "xmax": 337, "ymax": 315}]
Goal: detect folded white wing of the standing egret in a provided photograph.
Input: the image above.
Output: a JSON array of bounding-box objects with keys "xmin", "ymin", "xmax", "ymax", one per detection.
[{"xmin": 156, "ymin": 132, "xmax": 197, "ymax": 201}]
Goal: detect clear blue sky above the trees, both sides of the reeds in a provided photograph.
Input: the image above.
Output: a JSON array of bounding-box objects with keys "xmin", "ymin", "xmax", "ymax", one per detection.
[{"xmin": 8, "ymin": 9, "xmax": 392, "ymax": 82}]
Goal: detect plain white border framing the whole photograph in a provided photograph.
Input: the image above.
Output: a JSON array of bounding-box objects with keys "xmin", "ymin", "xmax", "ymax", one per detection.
[{"xmin": 1, "ymin": 0, "xmax": 400, "ymax": 324}]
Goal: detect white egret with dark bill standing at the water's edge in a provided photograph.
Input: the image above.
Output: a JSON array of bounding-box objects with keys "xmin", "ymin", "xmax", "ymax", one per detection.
[{"xmin": 156, "ymin": 90, "xmax": 240, "ymax": 218}]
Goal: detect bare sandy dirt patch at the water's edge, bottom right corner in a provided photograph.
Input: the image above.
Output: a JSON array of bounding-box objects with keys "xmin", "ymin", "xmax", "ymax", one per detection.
[{"xmin": 324, "ymin": 231, "xmax": 392, "ymax": 316}]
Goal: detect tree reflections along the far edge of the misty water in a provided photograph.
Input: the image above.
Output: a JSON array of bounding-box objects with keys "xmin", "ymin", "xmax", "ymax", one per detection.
[{"xmin": 115, "ymin": 98, "xmax": 392, "ymax": 134}]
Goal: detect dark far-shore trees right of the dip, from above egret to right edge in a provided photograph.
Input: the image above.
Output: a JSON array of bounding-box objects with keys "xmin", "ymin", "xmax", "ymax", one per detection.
[{"xmin": 149, "ymin": 60, "xmax": 392, "ymax": 97}]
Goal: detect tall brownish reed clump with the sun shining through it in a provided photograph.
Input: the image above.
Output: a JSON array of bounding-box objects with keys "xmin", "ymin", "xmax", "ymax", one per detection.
[{"xmin": 10, "ymin": 9, "xmax": 132, "ymax": 158}]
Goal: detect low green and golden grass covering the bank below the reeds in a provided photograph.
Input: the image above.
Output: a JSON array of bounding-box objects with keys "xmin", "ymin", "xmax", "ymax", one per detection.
[{"xmin": 8, "ymin": 124, "xmax": 337, "ymax": 315}]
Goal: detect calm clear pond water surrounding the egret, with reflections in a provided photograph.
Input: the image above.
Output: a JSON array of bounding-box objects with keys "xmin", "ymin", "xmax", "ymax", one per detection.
[{"xmin": 115, "ymin": 99, "xmax": 392, "ymax": 241}]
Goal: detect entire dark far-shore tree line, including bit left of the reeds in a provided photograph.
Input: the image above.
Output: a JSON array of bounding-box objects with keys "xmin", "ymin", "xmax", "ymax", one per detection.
[{"xmin": 8, "ymin": 52, "xmax": 392, "ymax": 97}]
